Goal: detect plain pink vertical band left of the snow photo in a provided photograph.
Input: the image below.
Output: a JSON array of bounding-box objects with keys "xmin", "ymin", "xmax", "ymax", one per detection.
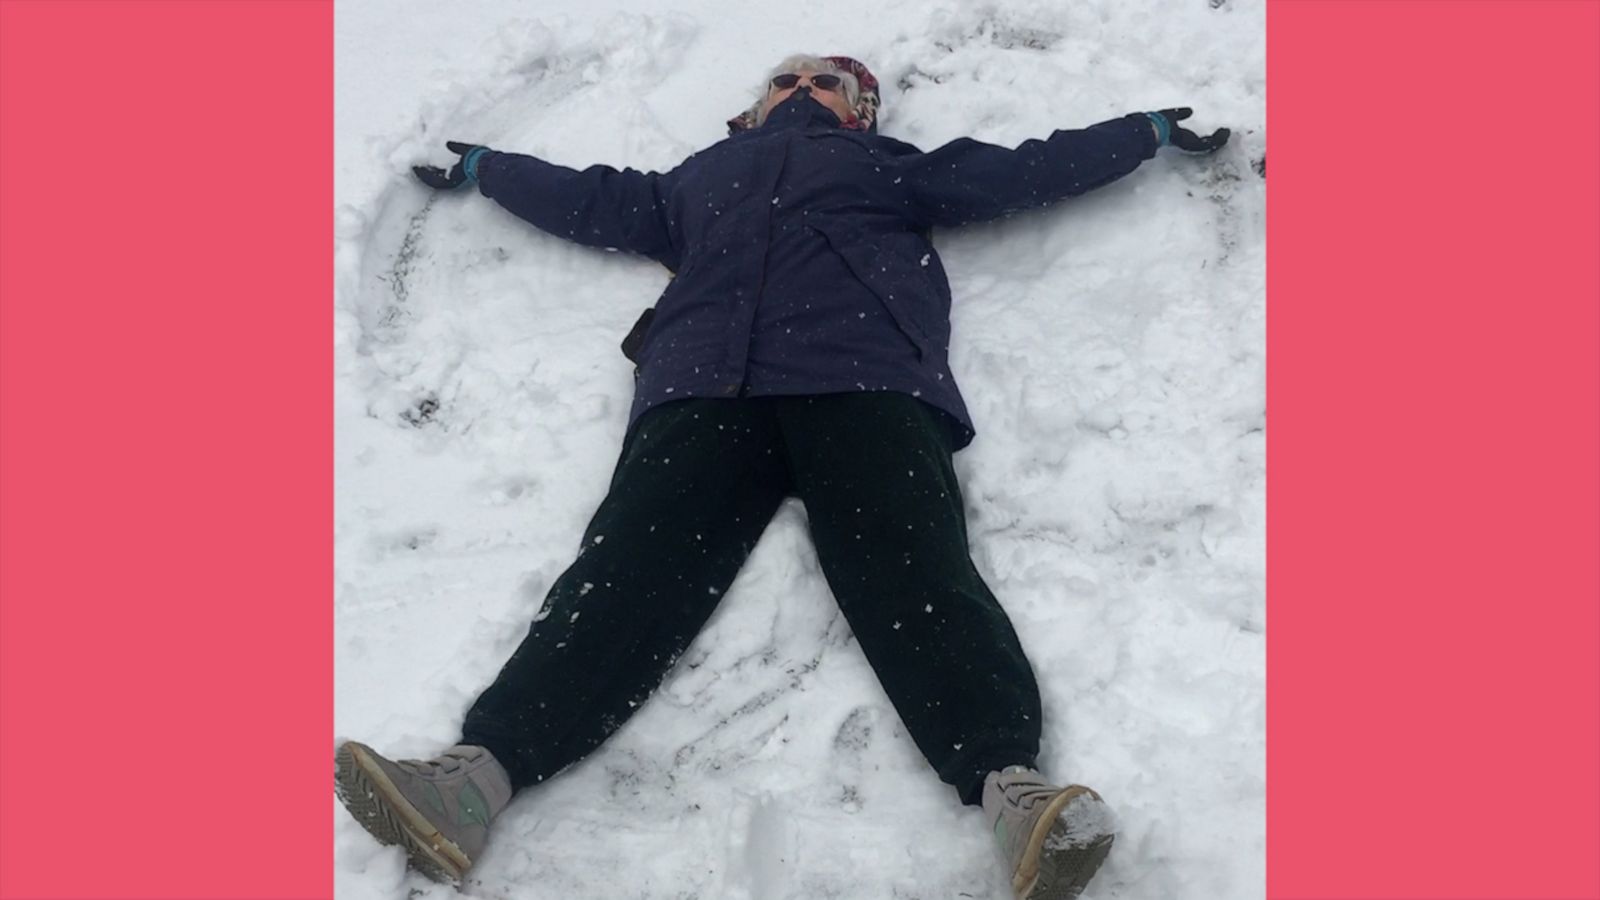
[{"xmin": 0, "ymin": 0, "xmax": 333, "ymax": 898}]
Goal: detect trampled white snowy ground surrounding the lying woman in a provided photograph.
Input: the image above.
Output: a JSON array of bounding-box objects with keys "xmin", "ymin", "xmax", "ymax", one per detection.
[{"xmin": 330, "ymin": 0, "xmax": 1266, "ymax": 900}]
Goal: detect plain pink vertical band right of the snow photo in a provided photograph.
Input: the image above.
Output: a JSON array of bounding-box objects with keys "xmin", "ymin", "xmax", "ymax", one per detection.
[{"xmin": 1260, "ymin": 0, "xmax": 1600, "ymax": 900}]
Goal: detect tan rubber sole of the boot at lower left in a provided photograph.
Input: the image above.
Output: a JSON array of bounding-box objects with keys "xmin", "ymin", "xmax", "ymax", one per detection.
[{"xmin": 333, "ymin": 741, "xmax": 472, "ymax": 884}]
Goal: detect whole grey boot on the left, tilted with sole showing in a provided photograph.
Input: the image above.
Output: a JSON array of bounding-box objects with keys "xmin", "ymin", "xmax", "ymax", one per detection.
[{"xmin": 333, "ymin": 741, "xmax": 512, "ymax": 884}]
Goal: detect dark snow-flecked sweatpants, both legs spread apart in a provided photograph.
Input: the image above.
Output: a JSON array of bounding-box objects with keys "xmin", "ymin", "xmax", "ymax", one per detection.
[{"xmin": 462, "ymin": 392, "xmax": 1040, "ymax": 804}]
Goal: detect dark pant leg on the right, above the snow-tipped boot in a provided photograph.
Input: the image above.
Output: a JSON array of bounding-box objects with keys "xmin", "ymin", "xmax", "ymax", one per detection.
[{"xmin": 779, "ymin": 392, "xmax": 1040, "ymax": 804}]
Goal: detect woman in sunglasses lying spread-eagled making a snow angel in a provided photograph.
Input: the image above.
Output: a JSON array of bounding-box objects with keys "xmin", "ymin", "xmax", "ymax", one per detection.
[{"xmin": 336, "ymin": 56, "xmax": 1229, "ymax": 898}]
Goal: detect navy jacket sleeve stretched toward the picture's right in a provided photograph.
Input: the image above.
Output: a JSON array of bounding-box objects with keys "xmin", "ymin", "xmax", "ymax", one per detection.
[{"xmin": 901, "ymin": 112, "xmax": 1160, "ymax": 226}]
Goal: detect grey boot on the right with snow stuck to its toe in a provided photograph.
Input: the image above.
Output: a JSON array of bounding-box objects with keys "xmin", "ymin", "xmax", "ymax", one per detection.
[{"xmin": 984, "ymin": 765, "xmax": 1117, "ymax": 900}]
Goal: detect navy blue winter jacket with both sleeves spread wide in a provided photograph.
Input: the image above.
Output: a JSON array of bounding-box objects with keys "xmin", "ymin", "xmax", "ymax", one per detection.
[{"xmin": 477, "ymin": 91, "xmax": 1158, "ymax": 448}]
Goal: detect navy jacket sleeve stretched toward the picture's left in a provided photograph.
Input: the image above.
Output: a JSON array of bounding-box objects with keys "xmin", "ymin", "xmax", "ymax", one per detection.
[{"xmin": 477, "ymin": 151, "xmax": 682, "ymax": 271}]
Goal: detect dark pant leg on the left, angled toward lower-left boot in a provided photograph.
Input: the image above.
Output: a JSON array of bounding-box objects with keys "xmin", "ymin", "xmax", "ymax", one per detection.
[{"xmin": 462, "ymin": 399, "xmax": 790, "ymax": 788}]
